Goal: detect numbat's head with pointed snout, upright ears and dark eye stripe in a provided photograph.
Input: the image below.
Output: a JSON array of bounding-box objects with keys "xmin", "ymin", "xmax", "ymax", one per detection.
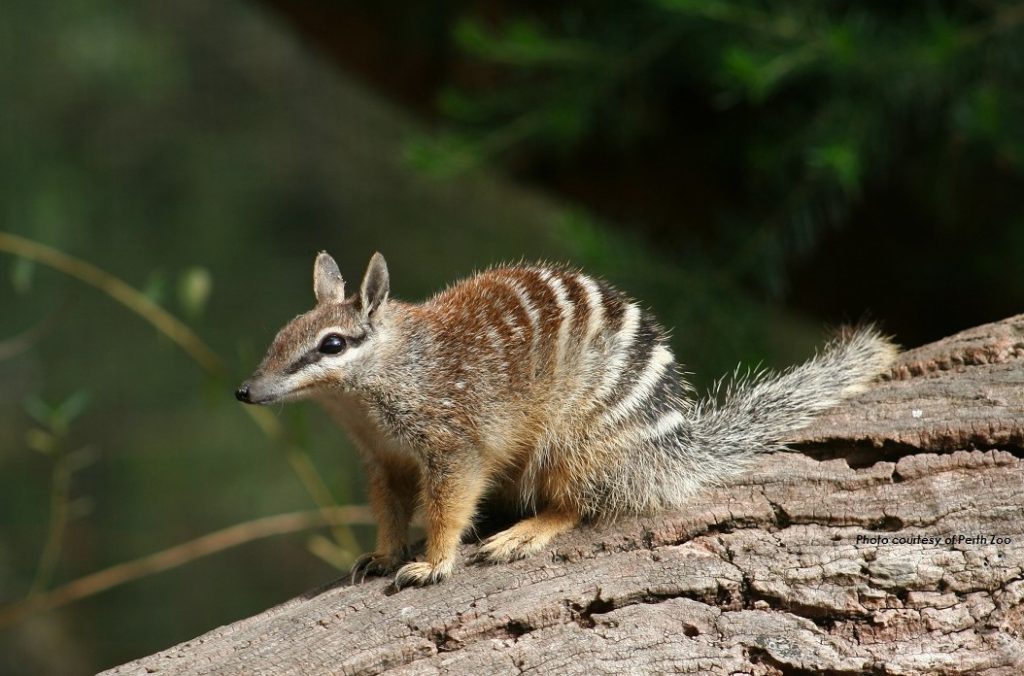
[{"xmin": 236, "ymin": 253, "xmax": 388, "ymax": 404}]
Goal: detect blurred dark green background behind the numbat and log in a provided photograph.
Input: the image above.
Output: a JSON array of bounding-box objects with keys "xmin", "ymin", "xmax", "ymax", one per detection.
[{"xmin": 0, "ymin": 0, "xmax": 1024, "ymax": 674}]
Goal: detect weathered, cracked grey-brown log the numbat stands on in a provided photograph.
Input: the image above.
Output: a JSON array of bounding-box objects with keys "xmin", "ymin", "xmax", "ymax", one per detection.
[{"xmin": 105, "ymin": 315, "xmax": 1024, "ymax": 675}]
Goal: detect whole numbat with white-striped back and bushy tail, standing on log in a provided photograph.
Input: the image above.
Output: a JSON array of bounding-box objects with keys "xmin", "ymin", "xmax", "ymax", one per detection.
[{"xmin": 236, "ymin": 253, "xmax": 896, "ymax": 587}]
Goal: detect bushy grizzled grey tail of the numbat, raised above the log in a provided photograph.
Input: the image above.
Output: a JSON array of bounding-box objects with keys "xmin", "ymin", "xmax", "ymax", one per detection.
[{"xmin": 690, "ymin": 326, "xmax": 898, "ymax": 478}]
